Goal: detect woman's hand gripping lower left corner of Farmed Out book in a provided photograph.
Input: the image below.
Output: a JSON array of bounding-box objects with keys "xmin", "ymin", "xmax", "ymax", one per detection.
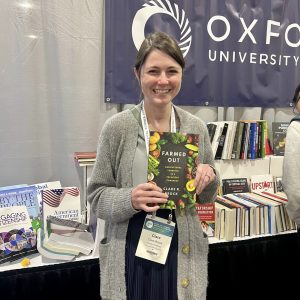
[{"xmin": 131, "ymin": 183, "xmax": 168, "ymax": 212}]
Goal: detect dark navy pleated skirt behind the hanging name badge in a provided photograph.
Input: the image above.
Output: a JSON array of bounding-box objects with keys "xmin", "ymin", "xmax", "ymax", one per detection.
[{"xmin": 125, "ymin": 209, "xmax": 178, "ymax": 300}]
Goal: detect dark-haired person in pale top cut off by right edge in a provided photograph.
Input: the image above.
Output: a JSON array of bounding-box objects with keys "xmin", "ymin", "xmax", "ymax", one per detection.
[{"xmin": 282, "ymin": 84, "xmax": 300, "ymax": 231}]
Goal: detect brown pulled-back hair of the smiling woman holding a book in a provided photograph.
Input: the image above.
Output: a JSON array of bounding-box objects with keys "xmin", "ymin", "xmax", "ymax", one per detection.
[{"xmin": 134, "ymin": 32, "xmax": 185, "ymax": 74}]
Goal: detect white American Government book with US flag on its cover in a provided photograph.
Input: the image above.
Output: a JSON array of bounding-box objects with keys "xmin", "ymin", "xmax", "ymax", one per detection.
[{"xmin": 42, "ymin": 187, "xmax": 82, "ymax": 239}]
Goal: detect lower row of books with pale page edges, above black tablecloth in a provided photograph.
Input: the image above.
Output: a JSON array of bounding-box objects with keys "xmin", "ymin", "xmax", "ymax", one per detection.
[{"xmin": 197, "ymin": 191, "xmax": 296, "ymax": 241}]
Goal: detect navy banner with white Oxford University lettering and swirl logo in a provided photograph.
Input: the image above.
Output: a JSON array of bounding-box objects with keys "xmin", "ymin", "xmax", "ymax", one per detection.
[{"xmin": 105, "ymin": 0, "xmax": 300, "ymax": 107}]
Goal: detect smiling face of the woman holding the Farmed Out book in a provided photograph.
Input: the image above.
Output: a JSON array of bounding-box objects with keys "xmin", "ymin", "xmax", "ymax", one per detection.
[{"xmin": 136, "ymin": 50, "xmax": 182, "ymax": 108}]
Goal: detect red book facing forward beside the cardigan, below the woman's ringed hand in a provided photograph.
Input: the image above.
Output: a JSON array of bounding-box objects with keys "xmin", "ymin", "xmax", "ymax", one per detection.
[{"xmin": 196, "ymin": 203, "xmax": 215, "ymax": 236}]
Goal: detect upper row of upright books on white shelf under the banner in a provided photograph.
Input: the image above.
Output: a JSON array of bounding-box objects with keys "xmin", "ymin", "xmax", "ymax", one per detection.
[{"xmin": 207, "ymin": 120, "xmax": 289, "ymax": 159}]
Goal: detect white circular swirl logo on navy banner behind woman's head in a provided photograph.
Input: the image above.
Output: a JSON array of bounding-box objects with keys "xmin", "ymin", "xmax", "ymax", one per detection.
[{"xmin": 131, "ymin": 0, "xmax": 192, "ymax": 57}]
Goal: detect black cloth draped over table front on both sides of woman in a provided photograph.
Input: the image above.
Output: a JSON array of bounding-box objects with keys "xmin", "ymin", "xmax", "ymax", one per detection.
[{"xmin": 0, "ymin": 233, "xmax": 300, "ymax": 300}]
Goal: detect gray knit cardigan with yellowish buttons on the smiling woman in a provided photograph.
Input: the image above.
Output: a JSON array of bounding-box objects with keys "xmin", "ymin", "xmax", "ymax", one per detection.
[{"xmin": 88, "ymin": 105, "xmax": 219, "ymax": 300}]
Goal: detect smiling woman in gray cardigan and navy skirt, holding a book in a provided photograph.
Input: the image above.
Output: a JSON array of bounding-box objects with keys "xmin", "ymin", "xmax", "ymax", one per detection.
[{"xmin": 88, "ymin": 32, "xmax": 219, "ymax": 300}]
